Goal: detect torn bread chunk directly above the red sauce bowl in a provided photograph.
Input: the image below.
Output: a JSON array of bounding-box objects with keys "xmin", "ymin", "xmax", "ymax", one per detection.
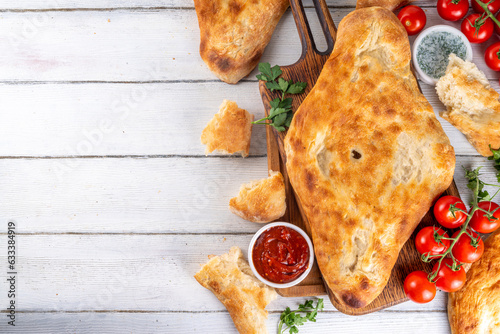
[{"xmin": 229, "ymin": 171, "xmax": 286, "ymax": 223}]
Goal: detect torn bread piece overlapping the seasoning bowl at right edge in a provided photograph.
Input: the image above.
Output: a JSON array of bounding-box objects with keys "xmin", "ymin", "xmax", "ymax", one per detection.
[{"xmin": 436, "ymin": 54, "xmax": 500, "ymax": 157}]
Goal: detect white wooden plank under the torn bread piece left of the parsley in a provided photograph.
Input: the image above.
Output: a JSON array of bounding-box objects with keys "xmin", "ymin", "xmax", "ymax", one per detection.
[{"xmin": 0, "ymin": 80, "xmax": 499, "ymax": 156}]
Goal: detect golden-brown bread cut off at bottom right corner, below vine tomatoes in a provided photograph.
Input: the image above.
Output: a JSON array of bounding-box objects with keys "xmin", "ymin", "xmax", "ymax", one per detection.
[{"xmin": 448, "ymin": 230, "xmax": 500, "ymax": 334}]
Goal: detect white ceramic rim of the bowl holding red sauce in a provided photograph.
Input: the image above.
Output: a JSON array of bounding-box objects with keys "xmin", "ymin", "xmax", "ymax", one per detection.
[{"xmin": 248, "ymin": 222, "xmax": 314, "ymax": 288}]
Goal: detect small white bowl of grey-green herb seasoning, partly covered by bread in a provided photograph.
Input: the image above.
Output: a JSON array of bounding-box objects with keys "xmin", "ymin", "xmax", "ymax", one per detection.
[{"xmin": 412, "ymin": 25, "xmax": 472, "ymax": 85}]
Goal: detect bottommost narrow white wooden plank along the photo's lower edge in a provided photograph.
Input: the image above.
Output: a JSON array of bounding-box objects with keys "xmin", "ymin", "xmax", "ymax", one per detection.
[{"xmin": 0, "ymin": 312, "xmax": 450, "ymax": 334}]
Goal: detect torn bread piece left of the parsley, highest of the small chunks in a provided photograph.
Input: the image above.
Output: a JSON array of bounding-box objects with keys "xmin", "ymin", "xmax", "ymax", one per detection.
[{"xmin": 201, "ymin": 100, "xmax": 254, "ymax": 157}]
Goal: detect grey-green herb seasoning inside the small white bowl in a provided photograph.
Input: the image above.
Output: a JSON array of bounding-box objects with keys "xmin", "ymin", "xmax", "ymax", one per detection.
[{"xmin": 417, "ymin": 31, "xmax": 467, "ymax": 80}]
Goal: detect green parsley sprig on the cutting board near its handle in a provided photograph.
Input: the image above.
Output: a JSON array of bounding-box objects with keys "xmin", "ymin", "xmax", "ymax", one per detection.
[{"xmin": 252, "ymin": 63, "xmax": 307, "ymax": 132}]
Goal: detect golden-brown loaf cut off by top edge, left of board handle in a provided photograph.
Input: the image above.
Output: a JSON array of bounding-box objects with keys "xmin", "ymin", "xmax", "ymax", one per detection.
[{"xmin": 194, "ymin": 0, "xmax": 289, "ymax": 83}]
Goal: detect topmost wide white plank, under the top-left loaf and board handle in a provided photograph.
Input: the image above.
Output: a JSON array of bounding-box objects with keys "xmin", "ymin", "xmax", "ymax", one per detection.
[{"xmin": 0, "ymin": 8, "xmax": 498, "ymax": 82}]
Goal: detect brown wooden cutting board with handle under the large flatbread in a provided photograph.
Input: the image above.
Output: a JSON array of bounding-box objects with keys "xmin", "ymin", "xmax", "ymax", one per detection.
[{"xmin": 259, "ymin": 0, "xmax": 459, "ymax": 315}]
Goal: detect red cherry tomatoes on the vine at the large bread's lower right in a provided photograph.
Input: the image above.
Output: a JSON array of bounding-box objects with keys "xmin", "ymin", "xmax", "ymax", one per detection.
[{"xmin": 404, "ymin": 196, "xmax": 500, "ymax": 303}]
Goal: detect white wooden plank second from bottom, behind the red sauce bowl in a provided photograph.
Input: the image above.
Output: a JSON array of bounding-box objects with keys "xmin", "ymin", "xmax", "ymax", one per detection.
[{"xmin": 0, "ymin": 232, "xmax": 446, "ymax": 312}]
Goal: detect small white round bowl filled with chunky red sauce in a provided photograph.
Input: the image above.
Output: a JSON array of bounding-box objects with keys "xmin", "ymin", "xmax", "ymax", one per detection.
[{"xmin": 248, "ymin": 222, "xmax": 314, "ymax": 288}]
